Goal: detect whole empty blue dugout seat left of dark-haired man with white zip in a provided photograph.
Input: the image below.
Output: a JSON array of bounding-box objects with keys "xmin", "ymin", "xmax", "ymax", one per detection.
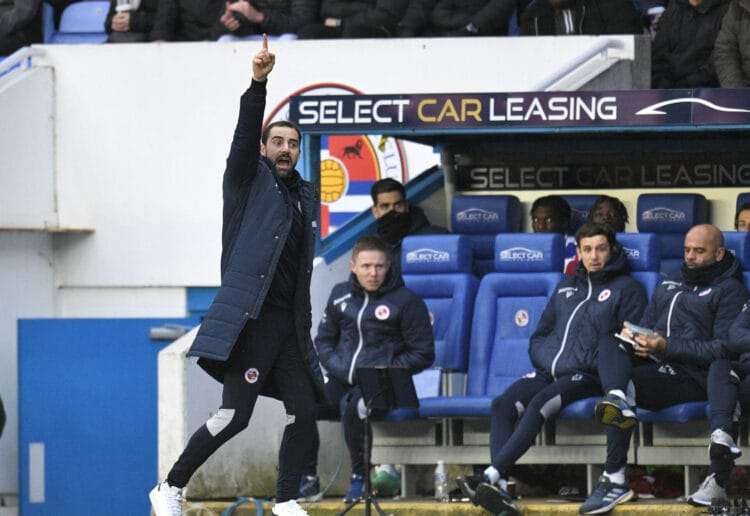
[{"xmin": 419, "ymin": 233, "xmax": 564, "ymax": 417}]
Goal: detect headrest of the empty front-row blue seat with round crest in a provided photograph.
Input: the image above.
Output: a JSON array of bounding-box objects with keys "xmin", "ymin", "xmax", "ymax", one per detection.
[{"xmin": 495, "ymin": 233, "xmax": 565, "ymax": 272}]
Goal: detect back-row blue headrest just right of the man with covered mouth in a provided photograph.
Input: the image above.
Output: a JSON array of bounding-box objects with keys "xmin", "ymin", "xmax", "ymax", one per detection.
[{"xmin": 451, "ymin": 195, "xmax": 522, "ymax": 235}]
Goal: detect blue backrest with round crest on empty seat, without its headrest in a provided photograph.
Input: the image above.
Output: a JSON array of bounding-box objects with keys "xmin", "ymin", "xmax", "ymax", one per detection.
[{"xmin": 466, "ymin": 267, "xmax": 562, "ymax": 396}]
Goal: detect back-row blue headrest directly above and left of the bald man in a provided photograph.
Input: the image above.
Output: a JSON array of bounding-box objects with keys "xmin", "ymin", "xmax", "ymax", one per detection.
[{"xmin": 638, "ymin": 194, "xmax": 708, "ymax": 234}]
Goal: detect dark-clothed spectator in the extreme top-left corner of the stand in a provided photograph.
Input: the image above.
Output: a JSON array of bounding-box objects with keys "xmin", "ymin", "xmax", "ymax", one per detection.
[{"xmin": 0, "ymin": 0, "xmax": 42, "ymax": 56}]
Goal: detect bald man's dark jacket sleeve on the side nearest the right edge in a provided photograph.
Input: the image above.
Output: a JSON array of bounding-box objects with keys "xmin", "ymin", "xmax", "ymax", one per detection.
[{"xmin": 666, "ymin": 282, "xmax": 747, "ymax": 368}]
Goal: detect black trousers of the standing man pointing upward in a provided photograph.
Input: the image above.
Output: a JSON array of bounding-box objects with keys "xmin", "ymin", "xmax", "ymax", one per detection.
[{"xmin": 167, "ymin": 305, "xmax": 316, "ymax": 502}]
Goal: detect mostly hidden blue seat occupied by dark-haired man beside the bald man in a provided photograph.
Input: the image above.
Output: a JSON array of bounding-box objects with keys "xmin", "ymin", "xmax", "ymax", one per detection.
[{"xmin": 558, "ymin": 233, "xmax": 663, "ymax": 419}]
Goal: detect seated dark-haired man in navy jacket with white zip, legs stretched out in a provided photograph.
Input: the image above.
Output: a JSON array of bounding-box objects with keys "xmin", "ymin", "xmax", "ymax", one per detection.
[{"xmin": 457, "ymin": 224, "xmax": 647, "ymax": 515}]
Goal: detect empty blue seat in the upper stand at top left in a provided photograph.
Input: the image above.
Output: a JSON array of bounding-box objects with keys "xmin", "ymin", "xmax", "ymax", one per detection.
[{"xmin": 51, "ymin": 0, "xmax": 109, "ymax": 43}]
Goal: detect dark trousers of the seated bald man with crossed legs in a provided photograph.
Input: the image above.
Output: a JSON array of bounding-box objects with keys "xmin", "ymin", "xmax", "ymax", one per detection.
[{"xmin": 598, "ymin": 339, "xmax": 708, "ymax": 473}]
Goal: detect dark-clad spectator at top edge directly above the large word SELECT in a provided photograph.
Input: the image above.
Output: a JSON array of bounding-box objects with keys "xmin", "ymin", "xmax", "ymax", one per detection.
[{"xmin": 297, "ymin": 0, "xmax": 408, "ymax": 39}]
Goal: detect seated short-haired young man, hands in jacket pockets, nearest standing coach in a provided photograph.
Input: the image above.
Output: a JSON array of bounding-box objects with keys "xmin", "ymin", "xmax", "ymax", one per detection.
[{"xmin": 300, "ymin": 236, "xmax": 435, "ymax": 502}]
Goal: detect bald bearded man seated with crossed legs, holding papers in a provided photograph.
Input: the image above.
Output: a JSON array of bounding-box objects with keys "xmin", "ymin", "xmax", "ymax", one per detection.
[{"xmin": 580, "ymin": 224, "xmax": 748, "ymax": 514}]
